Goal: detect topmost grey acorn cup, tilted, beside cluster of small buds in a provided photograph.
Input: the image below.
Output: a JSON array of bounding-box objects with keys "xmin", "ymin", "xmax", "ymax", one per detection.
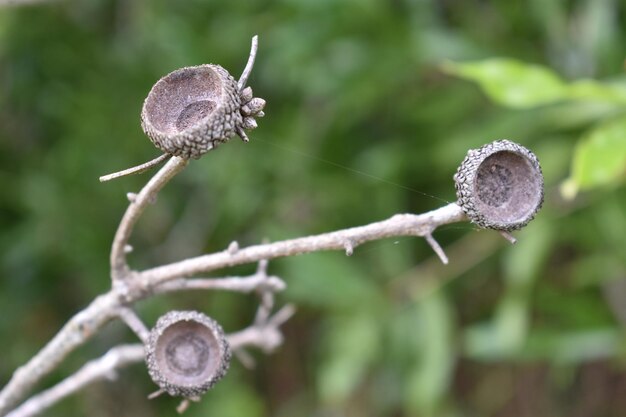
[{"xmin": 141, "ymin": 64, "xmax": 242, "ymax": 159}]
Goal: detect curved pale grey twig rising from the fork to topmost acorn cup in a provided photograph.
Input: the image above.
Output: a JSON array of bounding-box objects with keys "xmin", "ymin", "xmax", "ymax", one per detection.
[{"xmin": 111, "ymin": 156, "xmax": 189, "ymax": 282}]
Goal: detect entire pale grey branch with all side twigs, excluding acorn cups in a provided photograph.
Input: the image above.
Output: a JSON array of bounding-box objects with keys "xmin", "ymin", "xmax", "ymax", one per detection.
[{"xmin": 0, "ymin": 26, "xmax": 476, "ymax": 417}]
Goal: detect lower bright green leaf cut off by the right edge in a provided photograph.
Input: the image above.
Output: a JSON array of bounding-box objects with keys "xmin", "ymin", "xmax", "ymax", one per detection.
[{"xmin": 561, "ymin": 117, "xmax": 626, "ymax": 197}]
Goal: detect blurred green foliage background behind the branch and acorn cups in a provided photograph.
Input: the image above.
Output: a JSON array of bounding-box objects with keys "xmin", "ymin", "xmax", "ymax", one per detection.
[{"xmin": 0, "ymin": 0, "xmax": 626, "ymax": 417}]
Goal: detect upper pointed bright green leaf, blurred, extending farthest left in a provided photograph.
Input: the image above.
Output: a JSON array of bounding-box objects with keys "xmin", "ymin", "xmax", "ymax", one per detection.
[{"xmin": 443, "ymin": 58, "xmax": 567, "ymax": 109}]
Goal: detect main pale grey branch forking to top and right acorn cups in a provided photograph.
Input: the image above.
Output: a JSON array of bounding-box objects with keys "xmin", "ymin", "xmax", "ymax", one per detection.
[{"xmin": 0, "ymin": 202, "xmax": 466, "ymax": 415}]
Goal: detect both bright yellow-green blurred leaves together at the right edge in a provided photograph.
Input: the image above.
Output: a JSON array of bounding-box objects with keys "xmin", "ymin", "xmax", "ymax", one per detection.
[{"xmin": 444, "ymin": 59, "xmax": 626, "ymax": 199}]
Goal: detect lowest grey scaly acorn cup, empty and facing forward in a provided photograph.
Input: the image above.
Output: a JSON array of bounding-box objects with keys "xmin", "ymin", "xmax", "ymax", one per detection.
[{"xmin": 146, "ymin": 311, "xmax": 231, "ymax": 398}]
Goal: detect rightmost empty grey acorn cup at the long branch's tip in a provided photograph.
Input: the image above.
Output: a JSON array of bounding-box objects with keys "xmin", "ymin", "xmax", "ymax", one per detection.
[{"xmin": 454, "ymin": 140, "xmax": 543, "ymax": 231}]
